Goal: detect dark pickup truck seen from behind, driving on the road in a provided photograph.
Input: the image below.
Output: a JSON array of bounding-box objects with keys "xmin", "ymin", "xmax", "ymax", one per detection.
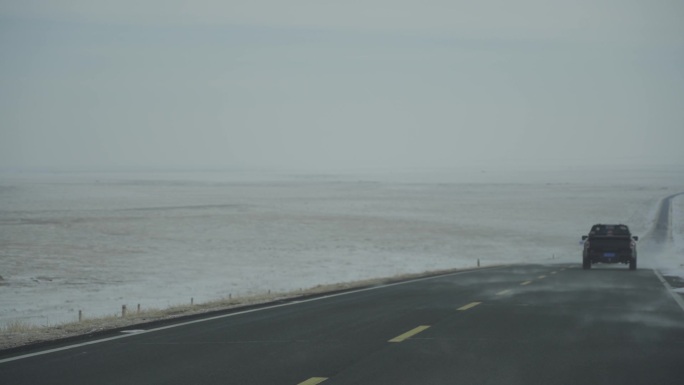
[{"xmin": 582, "ymin": 224, "xmax": 639, "ymax": 270}]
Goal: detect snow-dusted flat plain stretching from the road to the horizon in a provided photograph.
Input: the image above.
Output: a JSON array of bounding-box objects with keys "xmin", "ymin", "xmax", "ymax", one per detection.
[{"xmin": 0, "ymin": 167, "xmax": 684, "ymax": 327}]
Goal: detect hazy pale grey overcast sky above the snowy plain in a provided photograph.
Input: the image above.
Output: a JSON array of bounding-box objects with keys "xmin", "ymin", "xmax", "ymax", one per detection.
[{"xmin": 0, "ymin": 0, "xmax": 684, "ymax": 169}]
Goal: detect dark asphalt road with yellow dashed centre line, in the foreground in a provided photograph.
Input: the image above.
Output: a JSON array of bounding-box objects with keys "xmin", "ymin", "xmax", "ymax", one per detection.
[{"xmin": 0, "ymin": 262, "xmax": 684, "ymax": 385}]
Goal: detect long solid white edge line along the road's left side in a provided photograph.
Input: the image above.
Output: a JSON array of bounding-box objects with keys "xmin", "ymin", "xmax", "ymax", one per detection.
[{"xmin": 0, "ymin": 265, "xmax": 508, "ymax": 364}]
